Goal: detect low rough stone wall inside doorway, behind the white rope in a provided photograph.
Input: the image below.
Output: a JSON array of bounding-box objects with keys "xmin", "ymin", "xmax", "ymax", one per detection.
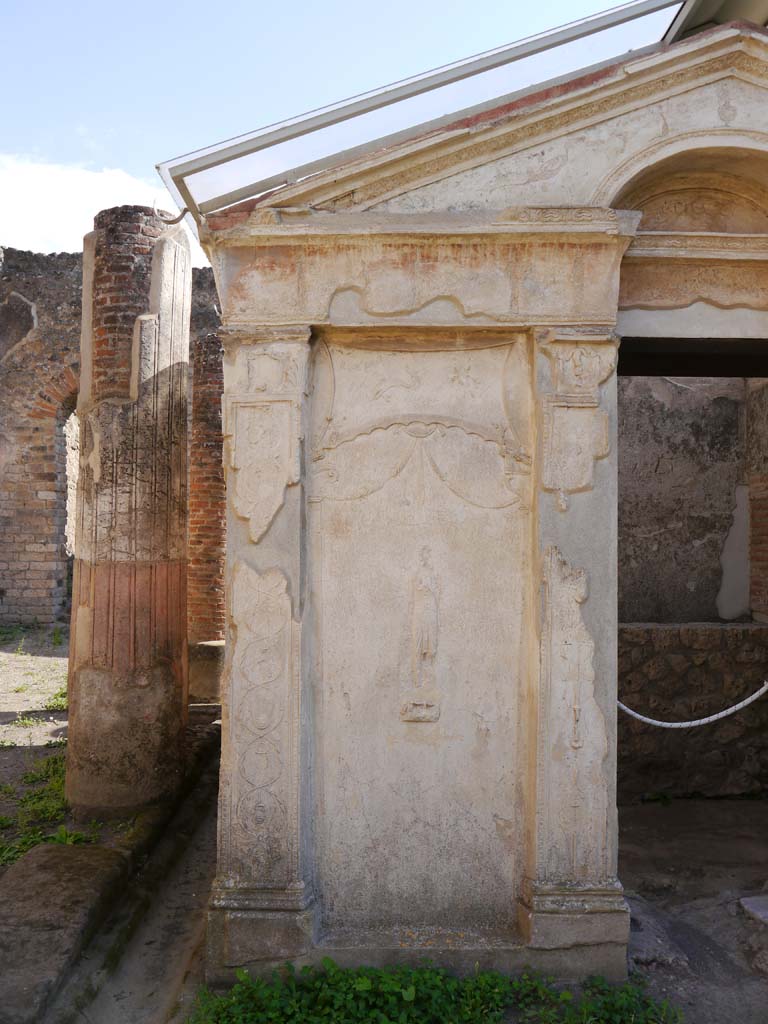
[{"xmin": 618, "ymin": 623, "xmax": 768, "ymax": 803}]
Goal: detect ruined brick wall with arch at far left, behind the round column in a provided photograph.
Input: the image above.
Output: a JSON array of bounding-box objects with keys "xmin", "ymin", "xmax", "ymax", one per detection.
[{"xmin": 0, "ymin": 249, "xmax": 82, "ymax": 624}]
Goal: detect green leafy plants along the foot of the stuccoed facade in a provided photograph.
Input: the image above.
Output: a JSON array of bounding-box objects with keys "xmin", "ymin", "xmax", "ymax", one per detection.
[{"xmin": 189, "ymin": 958, "xmax": 682, "ymax": 1024}]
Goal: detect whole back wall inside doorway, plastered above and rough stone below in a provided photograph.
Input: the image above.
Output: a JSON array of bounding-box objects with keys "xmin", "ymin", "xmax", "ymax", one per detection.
[{"xmin": 618, "ymin": 377, "xmax": 768, "ymax": 802}]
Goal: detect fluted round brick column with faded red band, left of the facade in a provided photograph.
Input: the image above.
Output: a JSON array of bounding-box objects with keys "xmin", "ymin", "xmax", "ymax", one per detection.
[{"xmin": 67, "ymin": 207, "xmax": 191, "ymax": 814}]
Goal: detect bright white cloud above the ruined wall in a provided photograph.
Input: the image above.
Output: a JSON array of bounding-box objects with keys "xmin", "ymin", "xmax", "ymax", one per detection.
[{"xmin": 0, "ymin": 154, "xmax": 208, "ymax": 266}]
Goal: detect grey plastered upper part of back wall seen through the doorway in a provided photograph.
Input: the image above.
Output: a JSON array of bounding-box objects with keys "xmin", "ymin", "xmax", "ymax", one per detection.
[{"xmin": 618, "ymin": 377, "xmax": 750, "ymax": 623}]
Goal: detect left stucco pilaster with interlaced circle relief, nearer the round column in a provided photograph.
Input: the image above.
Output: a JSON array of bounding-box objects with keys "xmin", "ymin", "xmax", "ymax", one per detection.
[{"xmin": 208, "ymin": 326, "xmax": 314, "ymax": 979}]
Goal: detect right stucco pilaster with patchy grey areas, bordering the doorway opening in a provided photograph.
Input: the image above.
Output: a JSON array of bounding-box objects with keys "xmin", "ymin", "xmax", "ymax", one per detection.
[{"xmin": 519, "ymin": 326, "xmax": 629, "ymax": 976}]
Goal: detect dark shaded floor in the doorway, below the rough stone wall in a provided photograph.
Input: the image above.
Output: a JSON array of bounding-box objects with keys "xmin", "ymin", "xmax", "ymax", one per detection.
[{"xmin": 620, "ymin": 800, "xmax": 768, "ymax": 1024}]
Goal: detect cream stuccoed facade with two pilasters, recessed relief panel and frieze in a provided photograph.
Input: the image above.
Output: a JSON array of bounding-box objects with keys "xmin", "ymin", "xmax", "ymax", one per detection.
[{"xmin": 209, "ymin": 209, "xmax": 634, "ymax": 979}]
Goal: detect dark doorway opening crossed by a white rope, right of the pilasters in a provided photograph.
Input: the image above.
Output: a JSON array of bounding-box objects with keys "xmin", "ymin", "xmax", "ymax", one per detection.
[{"xmin": 617, "ymin": 338, "xmax": 768, "ymax": 1021}]
